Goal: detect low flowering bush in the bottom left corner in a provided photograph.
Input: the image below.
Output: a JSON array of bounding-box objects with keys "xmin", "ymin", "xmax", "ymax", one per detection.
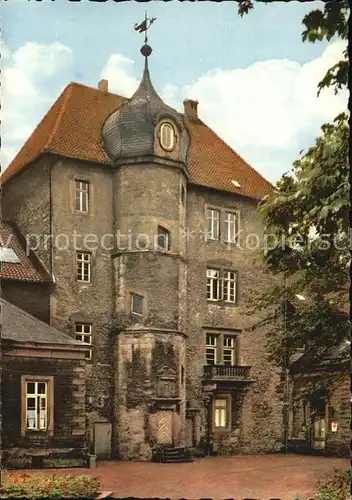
[{"xmin": 0, "ymin": 473, "xmax": 100, "ymax": 499}]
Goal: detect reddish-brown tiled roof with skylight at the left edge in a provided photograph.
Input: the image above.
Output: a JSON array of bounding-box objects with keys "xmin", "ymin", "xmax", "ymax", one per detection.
[{"xmin": 0, "ymin": 220, "xmax": 52, "ymax": 283}]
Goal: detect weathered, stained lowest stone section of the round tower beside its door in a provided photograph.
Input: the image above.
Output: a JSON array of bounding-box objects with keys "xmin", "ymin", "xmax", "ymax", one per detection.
[{"xmin": 115, "ymin": 331, "xmax": 185, "ymax": 460}]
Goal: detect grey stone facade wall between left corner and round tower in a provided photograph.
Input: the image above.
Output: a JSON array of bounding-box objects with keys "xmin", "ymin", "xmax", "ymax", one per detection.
[{"xmin": 48, "ymin": 159, "xmax": 114, "ymax": 435}]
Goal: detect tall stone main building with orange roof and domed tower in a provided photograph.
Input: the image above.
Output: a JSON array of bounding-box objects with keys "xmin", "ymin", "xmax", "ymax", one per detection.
[{"xmin": 2, "ymin": 46, "xmax": 283, "ymax": 460}]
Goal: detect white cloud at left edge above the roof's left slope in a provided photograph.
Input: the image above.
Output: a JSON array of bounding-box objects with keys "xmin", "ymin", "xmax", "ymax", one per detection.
[{"xmin": 1, "ymin": 42, "xmax": 73, "ymax": 168}]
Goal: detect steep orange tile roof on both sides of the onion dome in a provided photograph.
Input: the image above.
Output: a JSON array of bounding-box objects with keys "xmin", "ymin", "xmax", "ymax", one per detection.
[{"xmin": 2, "ymin": 83, "xmax": 273, "ymax": 199}]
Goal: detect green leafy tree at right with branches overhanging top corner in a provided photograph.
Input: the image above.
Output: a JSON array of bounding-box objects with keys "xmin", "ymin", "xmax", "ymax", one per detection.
[{"xmin": 239, "ymin": 0, "xmax": 350, "ymax": 398}]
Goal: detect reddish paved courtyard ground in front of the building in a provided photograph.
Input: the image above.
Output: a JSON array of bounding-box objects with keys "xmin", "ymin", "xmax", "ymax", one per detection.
[{"xmin": 12, "ymin": 454, "xmax": 349, "ymax": 500}]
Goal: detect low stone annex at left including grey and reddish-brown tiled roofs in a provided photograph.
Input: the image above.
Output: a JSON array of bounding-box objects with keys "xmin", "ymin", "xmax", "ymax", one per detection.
[{"xmin": 0, "ymin": 221, "xmax": 88, "ymax": 467}]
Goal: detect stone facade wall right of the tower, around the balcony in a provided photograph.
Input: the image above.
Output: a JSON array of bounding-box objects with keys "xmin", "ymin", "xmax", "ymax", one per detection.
[{"xmin": 187, "ymin": 188, "xmax": 283, "ymax": 452}]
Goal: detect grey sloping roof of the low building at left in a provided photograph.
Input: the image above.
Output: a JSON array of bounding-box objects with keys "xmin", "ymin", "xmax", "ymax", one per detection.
[{"xmin": 0, "ymin": 299, "xmax": 80, "ymax": 345}]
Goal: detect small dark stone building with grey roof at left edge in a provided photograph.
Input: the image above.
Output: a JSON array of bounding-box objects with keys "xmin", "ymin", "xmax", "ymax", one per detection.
[{"xmin": 1, "ymin": 299, "xmax": 87, "ymax": 467}]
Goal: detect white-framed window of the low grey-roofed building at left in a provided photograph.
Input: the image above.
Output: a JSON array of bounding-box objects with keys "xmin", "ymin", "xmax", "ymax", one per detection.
[{"xmin": 25, "ymin": 380, "xmax": 48, "ymax": 431}]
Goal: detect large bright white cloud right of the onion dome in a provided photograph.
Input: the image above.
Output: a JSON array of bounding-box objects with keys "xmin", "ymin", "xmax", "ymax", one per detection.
[{"xmin": 175, "ymin": 41, "xmax": 348, "ymax": 180}]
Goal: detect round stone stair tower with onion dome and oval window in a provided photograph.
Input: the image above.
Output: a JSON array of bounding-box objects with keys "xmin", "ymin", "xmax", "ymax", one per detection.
[{"xmin": 102, "ymin": 33, "xmax": 189, "ymax": 459}]
